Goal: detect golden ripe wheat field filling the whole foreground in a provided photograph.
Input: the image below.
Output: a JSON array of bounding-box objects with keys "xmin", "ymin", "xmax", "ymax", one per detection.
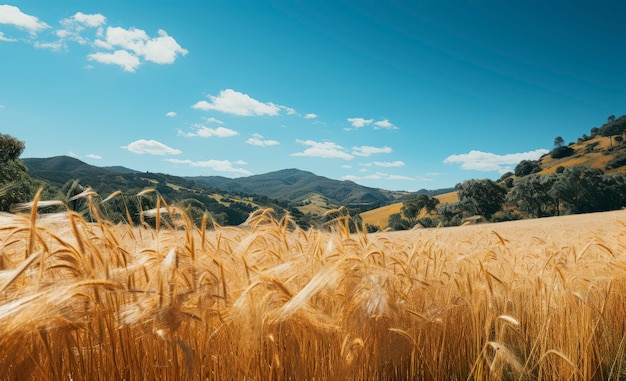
[{"xmin": 0, "ymin": 191, "xmax": 626, "ymax": 380}]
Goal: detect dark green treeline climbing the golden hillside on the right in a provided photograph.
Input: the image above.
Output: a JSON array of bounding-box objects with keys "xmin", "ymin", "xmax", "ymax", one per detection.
[{"xmin": 388, "ymin": 115, "xmax": 626, "ymax": 230}]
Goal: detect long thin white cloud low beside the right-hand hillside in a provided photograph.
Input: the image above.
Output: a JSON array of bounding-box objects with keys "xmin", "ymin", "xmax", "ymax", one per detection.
[{"xmin": 443, "ymin": 149, "xmax": 550, "ymax": 174}]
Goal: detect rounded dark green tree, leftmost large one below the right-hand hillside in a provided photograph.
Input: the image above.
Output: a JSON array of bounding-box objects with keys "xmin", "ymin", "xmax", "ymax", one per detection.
[{"xmin": 455, "ymin": 179, "xmax": 506, "ymax": 219}]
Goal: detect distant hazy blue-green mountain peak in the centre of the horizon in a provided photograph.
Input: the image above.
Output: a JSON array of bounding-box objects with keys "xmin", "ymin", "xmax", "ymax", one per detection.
[{"xmin": 187, "ymin": 168, "xmax": 404, "ymax": 206}]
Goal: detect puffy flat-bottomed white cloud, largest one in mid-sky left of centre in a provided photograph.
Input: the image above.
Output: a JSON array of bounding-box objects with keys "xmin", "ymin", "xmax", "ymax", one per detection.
[{"xmin": 191, "ymin": 89, "xmax": 281, "ymax": 116}]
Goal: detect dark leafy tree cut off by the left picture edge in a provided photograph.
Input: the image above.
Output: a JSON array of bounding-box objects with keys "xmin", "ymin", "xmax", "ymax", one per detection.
[{"xmin": 0, "ymin": 134, "xmax": 32, "ymax": 212}]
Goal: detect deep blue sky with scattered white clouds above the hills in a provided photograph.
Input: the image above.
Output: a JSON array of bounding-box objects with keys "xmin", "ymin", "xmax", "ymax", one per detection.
[{"xmin": 0, "ymin": 0, "xmax": 626, "ymax": 190}]
